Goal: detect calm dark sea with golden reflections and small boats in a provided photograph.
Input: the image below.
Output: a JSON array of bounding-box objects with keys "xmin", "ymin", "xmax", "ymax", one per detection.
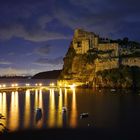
[{"xmin": 0, "ymin": 80, "xmax": 140, "ymax": 131}]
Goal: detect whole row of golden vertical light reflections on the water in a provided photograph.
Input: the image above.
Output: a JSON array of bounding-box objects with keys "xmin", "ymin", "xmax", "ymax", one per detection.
[{"xmin": 0, "ymin": 88, "xmax": 76, "ymax": 131}]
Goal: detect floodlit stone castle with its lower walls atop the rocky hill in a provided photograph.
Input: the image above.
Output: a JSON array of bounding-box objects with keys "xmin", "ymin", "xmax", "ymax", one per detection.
[{"xmin": 72, "ymin": 29, "xmax": 140, "ymax": 71}]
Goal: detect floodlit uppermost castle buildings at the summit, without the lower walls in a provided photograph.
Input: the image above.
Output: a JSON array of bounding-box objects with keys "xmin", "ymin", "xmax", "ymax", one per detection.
[{"xmin": 72, "ymin": 29, "xmax": 119, "ymax": 57}]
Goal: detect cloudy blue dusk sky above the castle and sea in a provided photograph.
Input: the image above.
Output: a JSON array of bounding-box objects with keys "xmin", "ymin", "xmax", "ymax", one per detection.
[{"xmin": 0, "ymin": 0, "xmax": 140, "ymax": 75}]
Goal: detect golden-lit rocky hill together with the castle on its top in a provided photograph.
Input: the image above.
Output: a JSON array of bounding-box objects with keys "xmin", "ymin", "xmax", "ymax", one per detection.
[{"xmin": 59, "ymin": 29, "xmax": 140, "ymax": 87}]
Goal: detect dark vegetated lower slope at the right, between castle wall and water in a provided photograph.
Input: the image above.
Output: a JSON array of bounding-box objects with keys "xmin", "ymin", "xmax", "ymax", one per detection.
[{"xmin": 96, "ymin": 66, "xmax": 140, "ymax": 88}]
